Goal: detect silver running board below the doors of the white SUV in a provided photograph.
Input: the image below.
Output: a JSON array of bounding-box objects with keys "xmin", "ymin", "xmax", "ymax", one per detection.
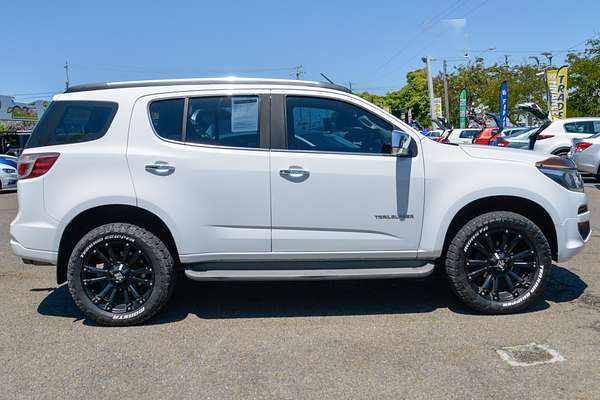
[{"xmin": 185, "ymin": 264, "xmax": 434, "ymax": 281}]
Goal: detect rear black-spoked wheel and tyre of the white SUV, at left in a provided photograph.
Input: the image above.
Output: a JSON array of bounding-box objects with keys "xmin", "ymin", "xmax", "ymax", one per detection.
[{"xmin": 67, "ymin": 223, "xmax": 175, "ymax": 326}]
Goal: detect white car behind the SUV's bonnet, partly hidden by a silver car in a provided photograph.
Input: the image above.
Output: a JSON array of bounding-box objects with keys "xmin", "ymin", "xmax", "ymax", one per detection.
[{"xmin": 533, "ymin": 117, "xmax": 600, "ymax": 156}]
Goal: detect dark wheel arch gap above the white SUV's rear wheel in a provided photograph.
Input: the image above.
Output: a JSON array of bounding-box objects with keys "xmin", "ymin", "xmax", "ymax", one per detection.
[{"xmin": 56, "ymin": 204, "xmax": 180, "ymax": 284}]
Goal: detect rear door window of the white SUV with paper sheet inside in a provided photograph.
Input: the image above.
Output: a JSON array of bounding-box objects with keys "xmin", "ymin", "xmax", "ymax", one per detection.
[{"xmin": 185, "ymin": 96, "xmax": 259, "ymax": 148}]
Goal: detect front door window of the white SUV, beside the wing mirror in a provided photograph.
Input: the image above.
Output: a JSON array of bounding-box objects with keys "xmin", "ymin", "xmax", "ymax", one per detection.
[{"xmin": 286, "ymin": 96, "xmax": 394, "ymax": 154}]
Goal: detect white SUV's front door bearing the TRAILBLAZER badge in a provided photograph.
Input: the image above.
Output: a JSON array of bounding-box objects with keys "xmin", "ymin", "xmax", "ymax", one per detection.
[{"xmin": 271, "ymin": 91, "xmax": 424, "ymax": 257}]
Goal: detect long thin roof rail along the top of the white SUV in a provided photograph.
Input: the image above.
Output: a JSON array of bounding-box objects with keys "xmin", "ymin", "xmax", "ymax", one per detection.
[{"xmin": 65, "ymin": 77, "xmax": 352, "ymax": 93}]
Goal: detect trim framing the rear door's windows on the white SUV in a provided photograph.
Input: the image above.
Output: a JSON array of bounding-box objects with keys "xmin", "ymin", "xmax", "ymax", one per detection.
[{"xmin": 146, "ymin": 92, "xmax": 271, "ymax": 151}]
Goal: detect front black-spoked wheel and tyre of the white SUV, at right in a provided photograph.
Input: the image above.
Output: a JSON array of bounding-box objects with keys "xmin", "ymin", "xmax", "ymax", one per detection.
[{"xmin": 446, "ymin": 211, "xmax": 552, "ymax": 314}]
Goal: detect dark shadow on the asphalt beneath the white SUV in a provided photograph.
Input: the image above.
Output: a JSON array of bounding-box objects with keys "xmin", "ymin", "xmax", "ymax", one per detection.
[{"xmin": 32, "ymin": 265, "xmax": 587, "ymax": 325}]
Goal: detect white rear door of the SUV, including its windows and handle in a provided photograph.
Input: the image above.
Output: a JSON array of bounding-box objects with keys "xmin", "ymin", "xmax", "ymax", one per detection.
[{"xmin": 127, "ymin": 90, "xmax": 271, "ymax": 262}]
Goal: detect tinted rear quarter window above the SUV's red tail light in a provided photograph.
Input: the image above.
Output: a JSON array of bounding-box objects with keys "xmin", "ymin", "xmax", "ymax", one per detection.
[{"xmin": 26, "ymin": 101, "xmax": 118, "ymax": 148}]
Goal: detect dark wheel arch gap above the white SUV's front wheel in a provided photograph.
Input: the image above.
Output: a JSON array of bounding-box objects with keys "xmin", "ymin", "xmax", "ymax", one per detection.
[{"xmin": 442, "ymin": 196, "xmax": 558, "ymax": 261}]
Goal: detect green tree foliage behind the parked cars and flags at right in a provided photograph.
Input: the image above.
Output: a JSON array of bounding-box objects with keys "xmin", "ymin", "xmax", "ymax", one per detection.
[{"xmin": 360, "ymin": 39, "xmax": 600, "ymax": 126}]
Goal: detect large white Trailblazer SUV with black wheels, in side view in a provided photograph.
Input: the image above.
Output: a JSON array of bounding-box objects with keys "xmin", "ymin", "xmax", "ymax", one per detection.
[{"xmin": 11, "ymin": 78, "xmax": 590, "ymax": 325}]
